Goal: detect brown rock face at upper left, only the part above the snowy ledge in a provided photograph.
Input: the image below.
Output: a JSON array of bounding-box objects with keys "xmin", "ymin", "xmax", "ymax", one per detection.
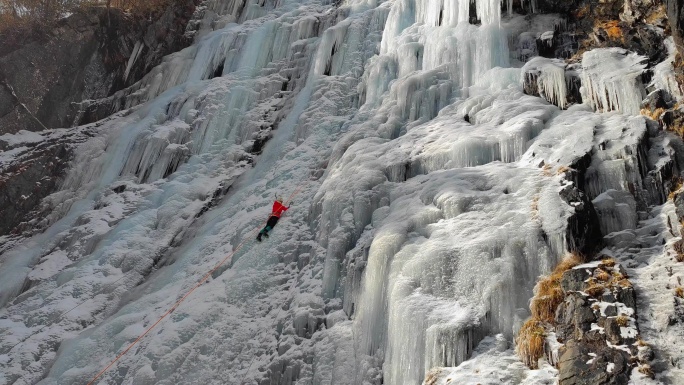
[{"xmin": 0, "ymin": 0, "xmax": 197, "ymax": 135}]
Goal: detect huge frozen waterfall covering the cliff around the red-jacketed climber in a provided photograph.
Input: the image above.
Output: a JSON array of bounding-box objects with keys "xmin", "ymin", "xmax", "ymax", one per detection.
[{"xmin": 0, "ymin": 0, "xmax": 672, "ymax": 385}]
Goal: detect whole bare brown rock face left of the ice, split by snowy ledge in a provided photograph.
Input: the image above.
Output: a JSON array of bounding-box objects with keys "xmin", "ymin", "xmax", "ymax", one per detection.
[{"xmin": 0, "ymin": 0, "xmax": 199, "ymax": 235}]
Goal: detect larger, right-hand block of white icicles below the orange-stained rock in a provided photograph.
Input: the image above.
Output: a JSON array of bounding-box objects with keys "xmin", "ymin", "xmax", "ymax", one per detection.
[{"xmin": 580, "ymin": 48, "xmax": 646, "ymax": 115}]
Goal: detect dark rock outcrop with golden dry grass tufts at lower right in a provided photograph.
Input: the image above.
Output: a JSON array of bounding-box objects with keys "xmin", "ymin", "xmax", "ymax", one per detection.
[{"xmin": 555, "ymin": 261, "xmax": 648, "ymax": 385}]
